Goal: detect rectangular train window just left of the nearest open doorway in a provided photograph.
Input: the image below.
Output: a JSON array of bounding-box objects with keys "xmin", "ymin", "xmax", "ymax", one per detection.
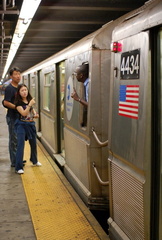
[{"xmin": 43, "ymin": 72, "xmax": 54, "ymax": 111}]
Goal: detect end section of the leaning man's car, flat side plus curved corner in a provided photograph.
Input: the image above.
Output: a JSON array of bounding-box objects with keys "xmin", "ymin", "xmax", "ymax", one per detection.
[{"xmin": 64, "ymin": 49, "xmax": 109, "ymax": 208}]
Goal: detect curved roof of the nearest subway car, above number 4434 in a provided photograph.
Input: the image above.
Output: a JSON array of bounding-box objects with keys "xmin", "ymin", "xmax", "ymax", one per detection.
[{"xmin": 113, "ymin": 0, "xmax": 162, "ymax": 41}]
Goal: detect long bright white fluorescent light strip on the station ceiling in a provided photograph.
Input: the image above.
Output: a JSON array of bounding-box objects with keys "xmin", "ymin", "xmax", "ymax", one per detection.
[{"xmin": 2, "ymin": 0, "xmax": 41, "ymax": 78}]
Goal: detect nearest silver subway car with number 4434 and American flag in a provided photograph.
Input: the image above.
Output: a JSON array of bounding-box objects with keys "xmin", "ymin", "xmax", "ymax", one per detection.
[{"xmin": 108, "ymin": 0, "xmax": 162, "ymax": 240}]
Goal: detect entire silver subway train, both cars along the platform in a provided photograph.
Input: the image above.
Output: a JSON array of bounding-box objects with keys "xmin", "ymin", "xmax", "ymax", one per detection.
[{"xmin": 22, "ymin": 0, "xmax": 162, "ymax": 240}]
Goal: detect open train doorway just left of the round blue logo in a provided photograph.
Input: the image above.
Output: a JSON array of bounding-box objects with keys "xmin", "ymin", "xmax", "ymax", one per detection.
[{"xmin": 55, "ymin": 62, "xmax": 65, "ymax": 162}]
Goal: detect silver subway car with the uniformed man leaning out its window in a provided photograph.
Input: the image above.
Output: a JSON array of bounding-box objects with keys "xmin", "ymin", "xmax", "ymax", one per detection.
[{"xmin": 23, "ymin": 18, "xmax": 122, "ymax": 209}]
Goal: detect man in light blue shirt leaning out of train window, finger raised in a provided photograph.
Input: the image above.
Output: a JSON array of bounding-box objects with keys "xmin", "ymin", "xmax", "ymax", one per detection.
[{"xmin": 71, "ymin": 63, "xmax": 89, "ymax": 107}]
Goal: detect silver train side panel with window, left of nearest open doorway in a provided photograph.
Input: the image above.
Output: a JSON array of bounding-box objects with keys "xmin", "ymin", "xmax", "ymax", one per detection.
[{"xmin": 39, "ymin": 64, "xmax": 57, "ymax": 153}]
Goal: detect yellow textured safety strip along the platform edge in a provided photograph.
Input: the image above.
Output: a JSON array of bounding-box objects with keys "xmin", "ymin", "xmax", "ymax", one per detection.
[{"xmin": 21, "ymin": 143, "xmax": 100, "ymax": 240}]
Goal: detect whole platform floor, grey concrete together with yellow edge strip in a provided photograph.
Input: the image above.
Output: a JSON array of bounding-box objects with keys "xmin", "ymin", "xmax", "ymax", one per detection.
[{"xmin": 0, "ymin": 96, "xmax": 109, "ymax": 240}]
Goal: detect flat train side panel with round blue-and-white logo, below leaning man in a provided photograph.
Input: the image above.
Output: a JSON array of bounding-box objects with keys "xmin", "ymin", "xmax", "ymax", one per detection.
[{"xmin": 64, "ymin": 51, "xmax": 90, "ymax": 202}]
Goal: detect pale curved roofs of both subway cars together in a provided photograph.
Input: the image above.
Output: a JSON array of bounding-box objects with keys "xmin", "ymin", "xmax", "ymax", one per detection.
[{"xmin": 22, "ymin": 0, "xmax": 162, "ymax": 75}]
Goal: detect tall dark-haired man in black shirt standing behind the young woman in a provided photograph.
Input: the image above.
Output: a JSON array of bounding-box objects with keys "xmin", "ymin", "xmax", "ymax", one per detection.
[{"xmin": 2, "ymin": 67, "xmax": 21, "ymax": 167}]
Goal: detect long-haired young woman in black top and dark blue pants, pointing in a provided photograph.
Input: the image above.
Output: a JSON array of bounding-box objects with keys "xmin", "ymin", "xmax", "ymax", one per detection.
[{"xmin": 15, "ymin": 84, "xmax": 42, "ymax": 174}]
